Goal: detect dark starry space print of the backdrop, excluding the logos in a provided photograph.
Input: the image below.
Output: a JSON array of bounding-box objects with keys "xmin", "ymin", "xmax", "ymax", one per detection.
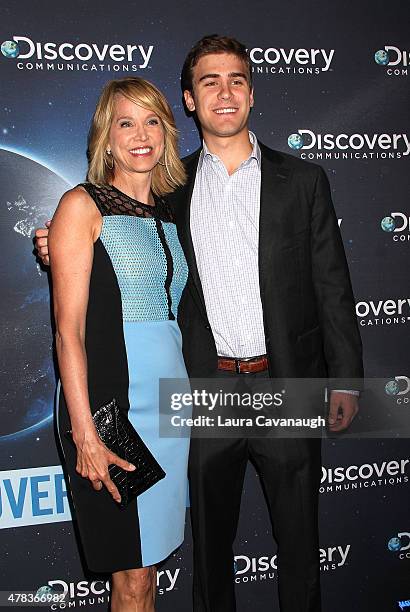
[{"xmin": 0, "ymin": 0, "xmax": 410, "ymax": 612}]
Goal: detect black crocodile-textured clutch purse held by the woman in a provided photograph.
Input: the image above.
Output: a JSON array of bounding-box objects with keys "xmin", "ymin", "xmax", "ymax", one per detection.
[{"xmin": 67, "ymin": 398, "xmax": 166, "ymax": 508}]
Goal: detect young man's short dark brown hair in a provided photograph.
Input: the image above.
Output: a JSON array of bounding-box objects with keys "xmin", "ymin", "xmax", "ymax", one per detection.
[{"xmin": 181, "ymin": 34, "xmax": 252, "ymax": 92}]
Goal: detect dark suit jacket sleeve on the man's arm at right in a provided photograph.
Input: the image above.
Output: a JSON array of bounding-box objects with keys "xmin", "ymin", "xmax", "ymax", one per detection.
[{"xmin": 311, "ymin": 167, "xmax": 363, "ymax": 389}]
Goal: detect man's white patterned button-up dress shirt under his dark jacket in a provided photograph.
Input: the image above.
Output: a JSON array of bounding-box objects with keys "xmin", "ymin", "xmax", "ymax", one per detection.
[{"xmin": 191, "ymin": 132, "xmax": 266, "ymax": 358}]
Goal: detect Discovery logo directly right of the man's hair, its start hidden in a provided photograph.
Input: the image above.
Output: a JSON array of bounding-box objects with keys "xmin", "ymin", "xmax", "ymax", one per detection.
[{"xmin": 248, "ymin": 47, "xmax": 335, "ymax": 76}]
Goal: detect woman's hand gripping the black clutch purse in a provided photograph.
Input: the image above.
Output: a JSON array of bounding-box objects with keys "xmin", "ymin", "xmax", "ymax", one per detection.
[{"xmin": 73, "ymin": 433, "xmax": 135, "ymax": 502}]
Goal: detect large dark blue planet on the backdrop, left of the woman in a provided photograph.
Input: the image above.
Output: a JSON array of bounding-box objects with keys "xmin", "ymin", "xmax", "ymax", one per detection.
[{"xmin": 0, "ymin": 149, "xmax": 70, "ymax": 444}]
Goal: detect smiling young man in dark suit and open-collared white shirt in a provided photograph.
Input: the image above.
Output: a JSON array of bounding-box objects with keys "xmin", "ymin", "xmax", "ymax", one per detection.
[{"xmin": 37, "ymin": 36, "xmax": 363, "ymax": 612}]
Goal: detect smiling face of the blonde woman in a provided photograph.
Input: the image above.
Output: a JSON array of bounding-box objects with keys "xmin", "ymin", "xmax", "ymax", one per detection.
[{"xmin": 107, "ymin": 95, "xmax": 165, "ymax": 177}]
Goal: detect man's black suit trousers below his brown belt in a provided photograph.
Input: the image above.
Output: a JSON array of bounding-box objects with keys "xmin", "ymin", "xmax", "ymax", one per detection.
[{"xmin": 189, "ymin": 372, "xmax": 321, "ymax": 612}]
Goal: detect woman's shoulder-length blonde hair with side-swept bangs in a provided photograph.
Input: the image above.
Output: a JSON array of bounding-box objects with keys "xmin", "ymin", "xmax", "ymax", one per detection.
[{"xmin": 87, "ymin": 77, "xmax": 186, "ymax": 196}]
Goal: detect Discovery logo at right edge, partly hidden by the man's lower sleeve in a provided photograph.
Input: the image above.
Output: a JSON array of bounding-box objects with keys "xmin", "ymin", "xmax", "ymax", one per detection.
[{"xmin": 356, "ymin": 298, "xmax": 410, "ymax": 327}]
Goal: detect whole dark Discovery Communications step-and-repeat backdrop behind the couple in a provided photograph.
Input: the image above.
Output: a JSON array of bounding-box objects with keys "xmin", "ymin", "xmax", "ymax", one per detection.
[{"xmin": 0, "ymin": 0, "xmax": 410, "ymax": 612}]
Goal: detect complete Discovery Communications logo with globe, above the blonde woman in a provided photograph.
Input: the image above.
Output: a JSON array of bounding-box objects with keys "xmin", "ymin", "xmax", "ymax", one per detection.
[{"xmin": 1, "ymin": 36, "xmax": 154, "ymax": 72}]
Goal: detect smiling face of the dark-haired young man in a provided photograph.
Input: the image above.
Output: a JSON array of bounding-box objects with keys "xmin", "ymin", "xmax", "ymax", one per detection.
[{"xmin": 184, "ymin": 53, "xmax": 253, "ymax": 138}]
